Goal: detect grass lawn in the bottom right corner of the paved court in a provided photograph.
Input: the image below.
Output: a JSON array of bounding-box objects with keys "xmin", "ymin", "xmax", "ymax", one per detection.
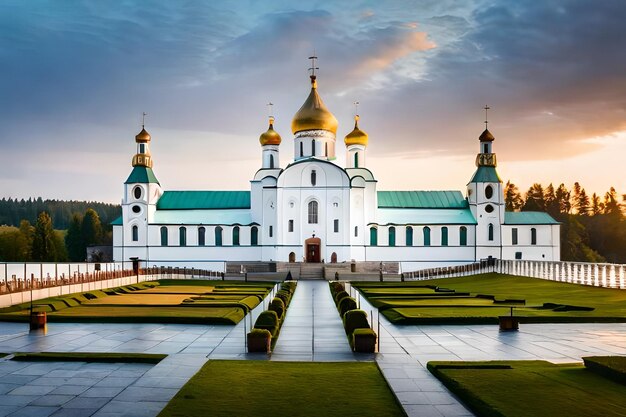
[{"xmin": 428, "ymin": 361, "xmax": 626, "ymax": 417}]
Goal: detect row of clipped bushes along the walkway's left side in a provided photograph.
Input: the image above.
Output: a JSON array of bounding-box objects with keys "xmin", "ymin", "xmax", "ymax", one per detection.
[{"xmin": 248, "ymin": 281, "xmax": 297, "ymax": 353}]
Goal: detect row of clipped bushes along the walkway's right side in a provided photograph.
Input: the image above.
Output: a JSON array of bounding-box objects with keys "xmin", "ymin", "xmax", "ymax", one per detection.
[{"xmin": 329, "ymin": 281, "xmax": 377, "ymax": 353}]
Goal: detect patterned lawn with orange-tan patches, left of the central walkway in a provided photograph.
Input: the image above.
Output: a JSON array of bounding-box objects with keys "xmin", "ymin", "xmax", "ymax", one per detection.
[{"xmin": 0, "ymin": 280, "xmax": 274, "ymax": 324}]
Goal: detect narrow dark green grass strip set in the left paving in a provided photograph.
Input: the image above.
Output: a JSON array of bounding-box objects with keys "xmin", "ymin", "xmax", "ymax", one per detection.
[{"xmin": 11, "ymin": 352, "xmax": 167, "ymax": 364}]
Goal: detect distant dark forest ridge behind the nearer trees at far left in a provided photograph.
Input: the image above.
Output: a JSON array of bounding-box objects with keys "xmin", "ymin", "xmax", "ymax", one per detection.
[{"xmin": 0, "ymin": 197, "xmax": 122, "ymax": 230}]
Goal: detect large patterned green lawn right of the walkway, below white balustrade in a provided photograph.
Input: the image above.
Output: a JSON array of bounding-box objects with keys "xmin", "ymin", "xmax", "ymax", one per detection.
[{"xmin": 353, "ymin": 273, "xmax": 626, "ymax": 324}]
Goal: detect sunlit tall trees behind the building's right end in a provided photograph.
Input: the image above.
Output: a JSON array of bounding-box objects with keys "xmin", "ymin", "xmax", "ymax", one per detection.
[{"xmin": 504, "ymin": 181, "xmax": 626, "ymax": 263}]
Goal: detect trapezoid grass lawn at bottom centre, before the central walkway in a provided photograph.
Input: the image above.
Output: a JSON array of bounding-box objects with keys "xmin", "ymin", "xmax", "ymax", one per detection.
[{"xmin": 159, "ymin": 360, "xmax": 405, "ymax": 417}]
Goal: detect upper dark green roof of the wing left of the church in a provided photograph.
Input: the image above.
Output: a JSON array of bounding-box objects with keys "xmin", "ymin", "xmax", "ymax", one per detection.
[{"xmin": 157, "ymin": 191, "xmax": 250, "ymax": 210}]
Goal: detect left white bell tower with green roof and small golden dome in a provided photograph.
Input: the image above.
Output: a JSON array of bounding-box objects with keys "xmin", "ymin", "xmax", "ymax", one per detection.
[{"xmin": 122, "ymin": 122, "xmax": 163, "ymax": 260}]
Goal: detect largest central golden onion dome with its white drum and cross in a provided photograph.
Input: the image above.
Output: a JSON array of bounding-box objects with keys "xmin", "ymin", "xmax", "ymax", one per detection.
[{"xmin": 291, "ymin": 56, "xmax": 339, "ymax": 161}]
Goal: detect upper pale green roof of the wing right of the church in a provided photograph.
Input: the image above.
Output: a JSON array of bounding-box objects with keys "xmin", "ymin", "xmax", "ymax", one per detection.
[{"xmin": 378, "ymin": 191, "xmax": 468, "ymax": 208}]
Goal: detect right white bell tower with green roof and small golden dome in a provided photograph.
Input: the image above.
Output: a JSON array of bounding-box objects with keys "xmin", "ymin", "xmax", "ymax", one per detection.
[{"xmin": 467, "ymin": 106, "xmax": 505, "ymax": 260}]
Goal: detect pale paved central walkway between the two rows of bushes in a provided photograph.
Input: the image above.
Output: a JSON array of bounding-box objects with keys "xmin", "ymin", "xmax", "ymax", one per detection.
[{"xmin": 271, "ymin": 281, "xmax": 360, "ymax": 362}]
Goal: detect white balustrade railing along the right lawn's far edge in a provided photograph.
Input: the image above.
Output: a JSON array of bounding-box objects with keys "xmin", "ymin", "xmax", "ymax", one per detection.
[{"xmin": 402, "ymin": 259, "xmax": 626, "ymax": 289}]
